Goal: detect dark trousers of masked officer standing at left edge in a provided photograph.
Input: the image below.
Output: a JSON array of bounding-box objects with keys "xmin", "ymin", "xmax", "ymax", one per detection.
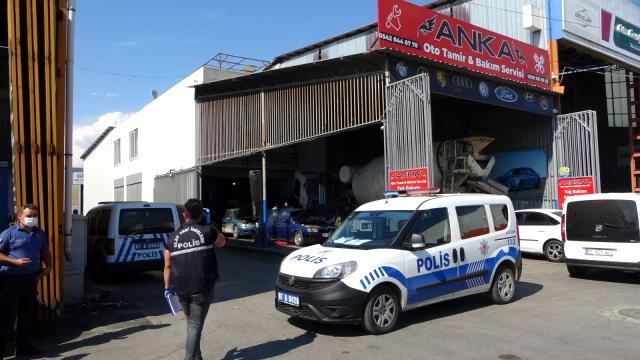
[{"xmin": 0, "ymin": 274, "xmax": 38, "ymax": 352}]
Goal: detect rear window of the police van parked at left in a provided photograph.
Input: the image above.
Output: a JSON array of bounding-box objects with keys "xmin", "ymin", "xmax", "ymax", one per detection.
[{"xmin": 118, "ymin": 208, "xmax": 174, "ymax": 235}]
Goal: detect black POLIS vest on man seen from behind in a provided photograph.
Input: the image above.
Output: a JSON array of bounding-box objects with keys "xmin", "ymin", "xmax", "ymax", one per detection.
[{"xmin": 167, "ymin": 223, "xmax": 218, "ymax": 296}]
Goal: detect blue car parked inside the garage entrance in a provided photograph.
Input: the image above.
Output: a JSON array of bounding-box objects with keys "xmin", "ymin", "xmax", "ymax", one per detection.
[{"xmin": 266, "ymin": 208, "xmax": 335, "ymax": 246}]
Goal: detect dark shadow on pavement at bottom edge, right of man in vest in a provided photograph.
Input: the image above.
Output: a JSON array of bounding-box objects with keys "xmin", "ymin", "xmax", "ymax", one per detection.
[{"xmin": 222, "ymin": 331, "xmax": 317, "ymax": 360}]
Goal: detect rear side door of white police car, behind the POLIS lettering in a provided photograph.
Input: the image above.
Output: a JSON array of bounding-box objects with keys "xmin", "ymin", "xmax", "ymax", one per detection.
[{"xmin": 453, "ymin": 204, "xmax": 498, "ymax": 296}]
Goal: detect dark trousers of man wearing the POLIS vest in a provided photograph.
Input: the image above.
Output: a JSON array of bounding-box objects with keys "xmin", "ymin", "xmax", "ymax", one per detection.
[{"xmin": 179, "ymin": 288, "xmax": 213, "ymax": 360}]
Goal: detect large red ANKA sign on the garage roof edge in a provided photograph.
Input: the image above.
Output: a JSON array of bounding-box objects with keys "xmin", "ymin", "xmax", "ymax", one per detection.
[{"xmin": 378, "ymin": 0, "xmax": 551, "ymax": 89}]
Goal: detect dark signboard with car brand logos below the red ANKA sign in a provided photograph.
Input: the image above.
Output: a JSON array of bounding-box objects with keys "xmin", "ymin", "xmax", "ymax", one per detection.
[{"xmin": 389, "ymin": 58, "xmax": 555, "ymax": 116}]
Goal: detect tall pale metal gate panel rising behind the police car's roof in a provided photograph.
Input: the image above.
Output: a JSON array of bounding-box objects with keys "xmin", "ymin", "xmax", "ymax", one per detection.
[{"xmin": 383, "ymin": 73, "xmax": 434, "ymax": 187}]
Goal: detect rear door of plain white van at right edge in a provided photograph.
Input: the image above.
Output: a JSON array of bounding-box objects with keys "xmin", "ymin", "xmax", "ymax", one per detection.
[{"xmin": 565, "ymin": 199, "xmax": 640, "ymax": 262}]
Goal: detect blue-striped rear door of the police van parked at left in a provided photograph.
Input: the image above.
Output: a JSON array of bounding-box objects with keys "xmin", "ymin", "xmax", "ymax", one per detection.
[{"xmin": 115, "ymin": 207, "xmax": 176, "ymax": 262}]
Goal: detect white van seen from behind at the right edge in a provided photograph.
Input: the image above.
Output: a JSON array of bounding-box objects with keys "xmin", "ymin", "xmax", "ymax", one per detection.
[{"xmin": 562, "ymin": 193, "xmax": 640, "ymax": 277}]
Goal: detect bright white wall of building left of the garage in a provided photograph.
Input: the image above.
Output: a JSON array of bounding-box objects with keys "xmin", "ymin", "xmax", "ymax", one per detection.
[{"xmin": 84, "ymin": 68, "xmax": 238, "ymax": 211}]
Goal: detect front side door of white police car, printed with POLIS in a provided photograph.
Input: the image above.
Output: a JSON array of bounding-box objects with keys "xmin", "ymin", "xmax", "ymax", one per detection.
[{"xmin": 403, "ymin": 208, "xmax": 459, "ymax": 306}]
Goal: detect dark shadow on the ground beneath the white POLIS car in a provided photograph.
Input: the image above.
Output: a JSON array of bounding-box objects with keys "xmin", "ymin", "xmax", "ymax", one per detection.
[{"xmin": 289, "ymin": 281, "xmax": 543, "ymax": 337}]
